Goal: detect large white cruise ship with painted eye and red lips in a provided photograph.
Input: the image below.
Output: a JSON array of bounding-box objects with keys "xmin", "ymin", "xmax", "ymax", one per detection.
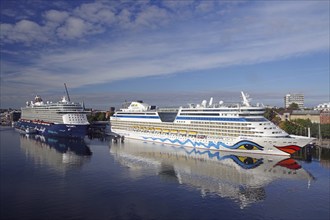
[{"xmin": 110, "ymin": 92, "xmax": 315, "ymax": 155}]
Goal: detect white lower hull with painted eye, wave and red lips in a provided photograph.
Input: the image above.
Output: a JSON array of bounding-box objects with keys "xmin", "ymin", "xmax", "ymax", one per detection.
[{"xmin": 112, "ymin": 129, "xmax": 313, "ymax": 156}]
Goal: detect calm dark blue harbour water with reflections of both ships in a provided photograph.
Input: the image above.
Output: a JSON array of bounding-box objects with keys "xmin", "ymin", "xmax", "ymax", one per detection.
[{"xmin": 0, "ymin": 127, "xmax": 330, "ymax": 220}]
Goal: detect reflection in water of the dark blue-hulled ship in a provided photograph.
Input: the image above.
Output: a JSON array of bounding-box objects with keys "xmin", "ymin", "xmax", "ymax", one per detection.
[{"xmin": 20, "ymin": 134, "xmax": 92, "ymax": 172}]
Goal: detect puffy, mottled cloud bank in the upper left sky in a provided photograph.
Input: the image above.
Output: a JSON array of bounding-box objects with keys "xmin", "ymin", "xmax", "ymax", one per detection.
[{"xmin": 1, "ymin": 2, "xmax": 174, "ymax": 45}]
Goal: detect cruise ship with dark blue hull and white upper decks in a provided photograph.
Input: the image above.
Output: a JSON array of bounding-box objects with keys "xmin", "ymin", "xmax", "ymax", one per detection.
[{"xmin": 15, "ymin": 96, "xmax": 89, "ymax": 138}]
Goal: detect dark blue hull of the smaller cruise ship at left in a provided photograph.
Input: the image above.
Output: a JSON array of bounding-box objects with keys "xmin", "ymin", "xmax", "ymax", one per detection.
[{"xmin": 14, "ymin": 120, "xmax": 88, "ymax": 138}]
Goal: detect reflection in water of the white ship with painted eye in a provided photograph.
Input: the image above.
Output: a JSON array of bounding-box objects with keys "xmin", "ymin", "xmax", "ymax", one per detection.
[{"xmin": 110, "ymin": 140, "xmax": 314, "ymax": 209}]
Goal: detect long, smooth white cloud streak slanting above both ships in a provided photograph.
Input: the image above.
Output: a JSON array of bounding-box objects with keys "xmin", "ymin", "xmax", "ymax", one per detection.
[{"xmin": 2, "ymin": 19, "xmax": 327, "ymax": 91}]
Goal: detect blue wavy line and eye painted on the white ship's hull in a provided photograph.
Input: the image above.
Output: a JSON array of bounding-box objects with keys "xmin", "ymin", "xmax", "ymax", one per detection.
[{"xmin": 142, "ymin": 137, "xmax": 264, "ymax": 150}]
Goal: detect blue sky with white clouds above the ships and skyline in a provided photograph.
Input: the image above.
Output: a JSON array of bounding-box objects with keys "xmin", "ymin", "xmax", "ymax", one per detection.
[{"xmin": 0, "ymin": 0, "xmax": 330, "ymax": 110}]
